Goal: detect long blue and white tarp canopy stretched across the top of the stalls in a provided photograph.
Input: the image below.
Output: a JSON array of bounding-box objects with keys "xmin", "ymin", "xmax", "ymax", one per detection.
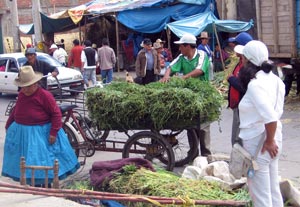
[{"xmin": 19, "ymin": 0, "xmax": 218, "ymax": 34}]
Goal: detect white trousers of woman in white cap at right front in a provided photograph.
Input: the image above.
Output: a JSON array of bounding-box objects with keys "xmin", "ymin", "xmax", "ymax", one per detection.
[{"xmin": 243, "ymin": 133, "xmax": 283, "ymax": 207}]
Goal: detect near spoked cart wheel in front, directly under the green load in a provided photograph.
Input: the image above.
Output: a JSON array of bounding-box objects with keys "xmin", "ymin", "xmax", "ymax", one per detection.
[{"xmin": 122, "ymin": 131, "xmax": 174, "ymax": 171}]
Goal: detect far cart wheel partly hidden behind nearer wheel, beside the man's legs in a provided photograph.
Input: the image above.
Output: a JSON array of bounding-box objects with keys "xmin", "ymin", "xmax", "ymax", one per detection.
[{"xmin": 159, "ymin": 130, "xmax": 199, "ymax": 167}]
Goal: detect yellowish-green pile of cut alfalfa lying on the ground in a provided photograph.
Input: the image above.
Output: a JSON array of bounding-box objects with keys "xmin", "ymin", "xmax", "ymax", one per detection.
[{"xmin": 102, "ymin": 165, "xmax": 251, "ymax": 207}]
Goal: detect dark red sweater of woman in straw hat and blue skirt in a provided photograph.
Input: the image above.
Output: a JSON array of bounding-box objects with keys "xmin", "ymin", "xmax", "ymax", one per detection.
[{"xmin": 5, "ymin": 88, "xmax": 62, "ymax": 136}]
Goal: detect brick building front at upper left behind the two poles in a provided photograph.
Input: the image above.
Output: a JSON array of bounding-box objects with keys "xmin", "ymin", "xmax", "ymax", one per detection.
[{"xmin": 0, "ymin": 0, "xmax": 90, "ymax": 53}]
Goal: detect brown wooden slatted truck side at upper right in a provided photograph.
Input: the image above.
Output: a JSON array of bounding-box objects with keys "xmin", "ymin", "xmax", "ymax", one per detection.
[{"xmin": 252, "ymin": 0, "xmax": 297, "ymax": 58}]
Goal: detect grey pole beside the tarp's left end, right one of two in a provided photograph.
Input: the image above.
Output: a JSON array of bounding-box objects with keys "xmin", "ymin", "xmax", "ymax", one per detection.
[{"xmin": 31, "ymin": 0, "xmax": 43, "ymax": 45}]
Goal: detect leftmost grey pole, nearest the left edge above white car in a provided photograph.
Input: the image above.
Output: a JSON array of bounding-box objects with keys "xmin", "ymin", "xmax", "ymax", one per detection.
[{"xmin": 10, "ymin": 0, "xmax": 21, "ymax": 52}]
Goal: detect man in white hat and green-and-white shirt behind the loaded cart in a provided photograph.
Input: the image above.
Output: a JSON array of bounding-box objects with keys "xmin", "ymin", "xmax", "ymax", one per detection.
[{"xmin": 161, "ymin": 33, "xmax": 211, "ymax": 156}]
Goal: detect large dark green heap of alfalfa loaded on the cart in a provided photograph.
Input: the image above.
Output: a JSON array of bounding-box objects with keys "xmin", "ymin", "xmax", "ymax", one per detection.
[{"xmin": 86, "ymin": 77, "xmax": 223, "ymax": 129}]
